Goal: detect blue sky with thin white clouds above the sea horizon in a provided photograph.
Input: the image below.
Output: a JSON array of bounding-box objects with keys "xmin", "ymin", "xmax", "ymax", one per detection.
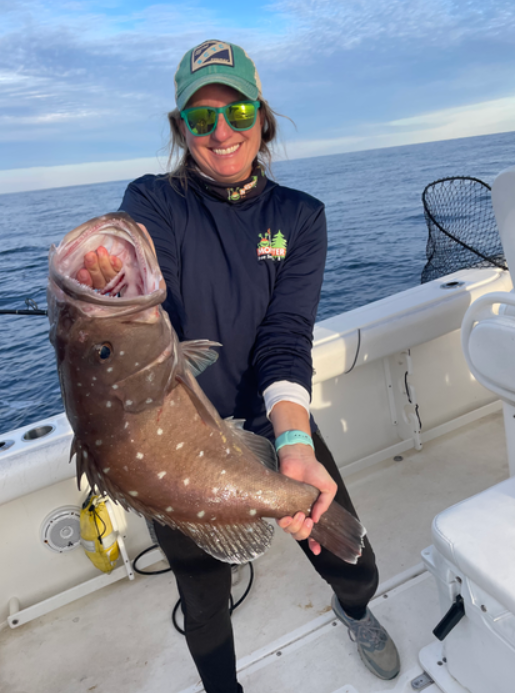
[{"xmin": 0, "ymin": 0, "xmax": 515, "ymax": 193}]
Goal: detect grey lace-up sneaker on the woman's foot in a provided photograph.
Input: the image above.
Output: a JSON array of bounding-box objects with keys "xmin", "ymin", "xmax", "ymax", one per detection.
[{"xmin": 331, "ymin": 595, "xmax": 401, "ymax": 681}]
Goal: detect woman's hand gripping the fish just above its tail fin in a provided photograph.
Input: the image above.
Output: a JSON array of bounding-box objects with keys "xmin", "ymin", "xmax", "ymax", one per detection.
[{"xmin": 277, "ymin": 444, "xmax": 337, "ymax": 556}]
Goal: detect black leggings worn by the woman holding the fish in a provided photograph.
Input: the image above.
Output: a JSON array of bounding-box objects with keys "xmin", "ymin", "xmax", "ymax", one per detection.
[{"xmin": 154, "ymin": 433, "xmax": 378, "ymax": 693}]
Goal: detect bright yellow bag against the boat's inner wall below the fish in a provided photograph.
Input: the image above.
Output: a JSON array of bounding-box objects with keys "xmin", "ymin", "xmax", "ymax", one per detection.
[{"xmin": 80, "ymin": 493, "xmax": 120, "ymax": 573}]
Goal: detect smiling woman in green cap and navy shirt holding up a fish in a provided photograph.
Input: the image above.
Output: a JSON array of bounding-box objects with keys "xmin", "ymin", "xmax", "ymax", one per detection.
[{"xmin": 79, "ymin": 41, "xmax": 400, "ymax": 693}]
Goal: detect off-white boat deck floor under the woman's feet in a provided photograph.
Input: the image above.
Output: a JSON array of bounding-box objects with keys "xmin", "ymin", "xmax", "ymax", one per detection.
[{"xmin": 0, "ymin": 413, "xmax": 508, "ymax": 693}]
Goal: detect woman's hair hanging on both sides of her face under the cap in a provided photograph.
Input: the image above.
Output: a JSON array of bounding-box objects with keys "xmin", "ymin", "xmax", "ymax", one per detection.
[{"xmin": 168, "ymin": 99, "xmax": 280, "ymax": 185}]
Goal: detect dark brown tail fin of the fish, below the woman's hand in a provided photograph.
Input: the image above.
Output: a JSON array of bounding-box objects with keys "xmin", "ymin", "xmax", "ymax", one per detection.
[{"xmin": 311, "ymin": 502, "xmax": 366, "ymax": 564}]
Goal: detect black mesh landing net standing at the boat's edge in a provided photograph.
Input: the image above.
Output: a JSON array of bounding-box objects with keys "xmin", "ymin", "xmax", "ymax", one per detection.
[{"xmin": 421, "ymin": 176, "xmax": 508, "ymax": 284}]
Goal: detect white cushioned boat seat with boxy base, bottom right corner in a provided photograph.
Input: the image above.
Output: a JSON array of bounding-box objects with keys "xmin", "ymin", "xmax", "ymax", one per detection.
[{"xmin": 420, "ymin": 477, "xmax": 515, "ymax": 693}]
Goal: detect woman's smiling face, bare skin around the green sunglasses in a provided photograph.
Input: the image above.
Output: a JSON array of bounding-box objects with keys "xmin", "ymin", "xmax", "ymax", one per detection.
[{"xmin": 181, "ymin": 84, "xmax": 263, "ymax": 184}]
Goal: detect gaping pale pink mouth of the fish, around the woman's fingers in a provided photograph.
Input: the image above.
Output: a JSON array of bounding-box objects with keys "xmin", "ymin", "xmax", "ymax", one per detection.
[{"xmin": 50, "ymin": 213, "xmax": 163, "ymax": 303}]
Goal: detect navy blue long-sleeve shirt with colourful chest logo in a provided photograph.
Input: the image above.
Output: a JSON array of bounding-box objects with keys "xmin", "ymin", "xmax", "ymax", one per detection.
[{"xmin": 120, "ymin": 175, "xmax": 327, "ymax": 439}]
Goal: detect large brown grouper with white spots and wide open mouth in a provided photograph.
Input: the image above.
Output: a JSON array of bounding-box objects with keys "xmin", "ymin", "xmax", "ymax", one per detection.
[{"xmin": 48, "ymin": 213, "xmax": 365, "ymax": 563}]
